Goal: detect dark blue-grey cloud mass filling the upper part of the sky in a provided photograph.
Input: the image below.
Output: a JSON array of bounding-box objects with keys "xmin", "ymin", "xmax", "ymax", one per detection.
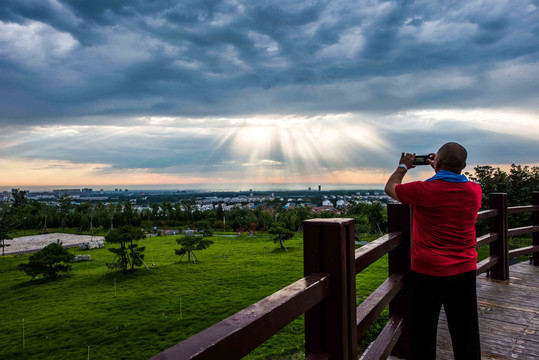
[{"xmin": 0, "ymin": 0, "xmax": 539, "ymax": 123}]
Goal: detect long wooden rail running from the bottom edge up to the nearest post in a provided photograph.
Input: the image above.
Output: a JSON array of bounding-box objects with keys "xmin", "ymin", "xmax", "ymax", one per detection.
[{"xmin": 151, "ymin": 274, "xmax": 329, "ymax": 360}]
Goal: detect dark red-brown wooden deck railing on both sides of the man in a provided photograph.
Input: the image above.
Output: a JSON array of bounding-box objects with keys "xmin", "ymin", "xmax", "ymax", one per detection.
[{"xmin": 152, "ymin": 193, "xmax": 539, "ymax": 360}]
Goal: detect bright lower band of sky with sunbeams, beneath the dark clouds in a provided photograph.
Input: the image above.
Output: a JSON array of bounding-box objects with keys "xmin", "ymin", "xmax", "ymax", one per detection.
[{"xmin": 0, "ymin": 109, "xmax": 539, "ymax": 189}]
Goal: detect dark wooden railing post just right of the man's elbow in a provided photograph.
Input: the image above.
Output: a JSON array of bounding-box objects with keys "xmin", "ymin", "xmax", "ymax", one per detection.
[{"xmin": 489, "ymin": 193, "xmax": 509, "ymax": 280}]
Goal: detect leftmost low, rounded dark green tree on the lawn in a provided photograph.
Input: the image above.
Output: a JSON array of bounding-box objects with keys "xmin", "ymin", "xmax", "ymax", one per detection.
[{"xmin": 17, "ymin": 242, "xmax": 75, "ymax": 279}]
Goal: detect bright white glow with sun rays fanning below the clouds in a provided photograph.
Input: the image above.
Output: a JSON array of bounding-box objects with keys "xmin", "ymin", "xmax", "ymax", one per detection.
[{"xmin": 213, "ymin": 114, "xmax": 387, "ymax": 183}]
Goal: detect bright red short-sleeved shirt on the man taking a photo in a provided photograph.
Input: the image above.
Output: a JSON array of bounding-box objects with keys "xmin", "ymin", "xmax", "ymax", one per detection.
[{"xmin": 395, "ymin": 180, "xmax": 481, "ymax": 276}]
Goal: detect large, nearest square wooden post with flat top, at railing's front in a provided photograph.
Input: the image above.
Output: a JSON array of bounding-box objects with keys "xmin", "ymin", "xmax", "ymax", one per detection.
[{"xmin": 303, "ymin": 219, "xmax": 357, "ymax": 360}]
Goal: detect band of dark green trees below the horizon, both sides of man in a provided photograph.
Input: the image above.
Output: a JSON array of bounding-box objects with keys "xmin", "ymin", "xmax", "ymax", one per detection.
[{"xmin": 0, "ymin": 164, "xmax": 539, "ymax": 242}]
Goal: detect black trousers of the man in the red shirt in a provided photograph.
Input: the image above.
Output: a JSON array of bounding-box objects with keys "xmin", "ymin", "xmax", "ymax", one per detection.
[{"xmin": 410, "ymin": 271, "xmax": 481, "ymax": 360}]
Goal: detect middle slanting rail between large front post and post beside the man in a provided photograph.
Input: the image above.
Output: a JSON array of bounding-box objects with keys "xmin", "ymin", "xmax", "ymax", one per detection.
[{"xmin": 356, "ymin": 274, "xmax": 404, "ymax": 340}]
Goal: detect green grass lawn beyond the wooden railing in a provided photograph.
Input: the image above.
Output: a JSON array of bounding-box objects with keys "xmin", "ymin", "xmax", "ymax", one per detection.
[{"xmin": 0, "ymin": 234, "xmax": 387, "ymax": 359}]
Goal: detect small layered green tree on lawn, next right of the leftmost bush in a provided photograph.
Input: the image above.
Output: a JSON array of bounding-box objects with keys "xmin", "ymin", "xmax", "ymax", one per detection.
[{"xmin": 105, "ymin": 225, "xmax": 146, "ymax": 274}]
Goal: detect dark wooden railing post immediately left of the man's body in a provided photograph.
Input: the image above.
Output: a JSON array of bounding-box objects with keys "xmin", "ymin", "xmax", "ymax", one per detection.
[{"xmin": 387, "ymin": 204, "xmax": 412, "ymax": 359}]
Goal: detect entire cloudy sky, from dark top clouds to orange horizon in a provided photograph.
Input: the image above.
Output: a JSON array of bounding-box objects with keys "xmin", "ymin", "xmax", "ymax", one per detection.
[{"xmin": 0, "ymin": 0, "xmax": 539, "ymax": 189}]
